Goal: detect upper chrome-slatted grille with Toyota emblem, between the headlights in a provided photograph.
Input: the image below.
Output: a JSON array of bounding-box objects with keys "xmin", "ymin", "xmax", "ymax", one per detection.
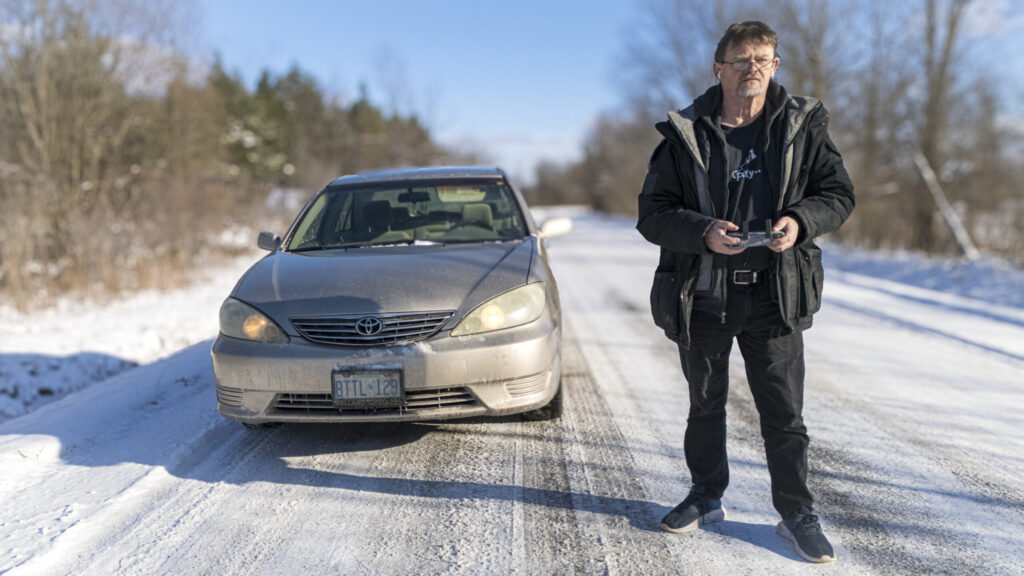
[{"xmin": 291, "ymin": 311, "xmax": 455, "ymax": 346}]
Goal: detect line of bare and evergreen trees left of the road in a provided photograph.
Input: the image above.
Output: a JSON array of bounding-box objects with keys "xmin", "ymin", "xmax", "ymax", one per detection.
[{"xmin": 0, "ymin": 0, "xmax": 472, "ymax": 305}]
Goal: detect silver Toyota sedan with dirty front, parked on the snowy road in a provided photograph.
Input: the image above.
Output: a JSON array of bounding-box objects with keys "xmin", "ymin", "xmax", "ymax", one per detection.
[{"xmin": 212, "ymin": 167, "xmax": 571, "ymax": 425}]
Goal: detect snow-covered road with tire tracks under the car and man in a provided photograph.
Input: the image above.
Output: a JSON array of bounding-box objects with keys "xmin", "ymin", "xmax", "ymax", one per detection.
[{"xmin": 0, "ymin": 216, "xmax": 1024, "ymax": 574}]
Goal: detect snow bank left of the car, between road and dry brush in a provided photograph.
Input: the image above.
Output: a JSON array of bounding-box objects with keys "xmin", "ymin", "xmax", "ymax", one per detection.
[{"xmin": 0, "ymin": 251, "xmax": 262, "ymax": 421}]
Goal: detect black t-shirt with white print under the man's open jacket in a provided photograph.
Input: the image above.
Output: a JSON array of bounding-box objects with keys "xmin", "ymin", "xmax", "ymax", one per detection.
[{"xmin": 722, "ymin": 113, "xmax": 772, "ymax": 270}]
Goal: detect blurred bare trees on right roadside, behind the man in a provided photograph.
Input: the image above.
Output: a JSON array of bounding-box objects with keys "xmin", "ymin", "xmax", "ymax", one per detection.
[{"xmin": 525, "ymin": 0, "xmax": 1024, "ymax": 261}]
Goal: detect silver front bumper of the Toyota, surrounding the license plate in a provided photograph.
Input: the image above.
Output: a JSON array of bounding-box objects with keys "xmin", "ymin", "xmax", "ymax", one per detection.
[{"xmin": 212, "ymin": 313, "xmax": 561, "ymax": 423}]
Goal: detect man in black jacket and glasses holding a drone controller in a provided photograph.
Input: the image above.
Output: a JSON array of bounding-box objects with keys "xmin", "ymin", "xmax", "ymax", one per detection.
[{"xmin": 637, "ymin": 22, "xmax": 854, "ymax": 562}]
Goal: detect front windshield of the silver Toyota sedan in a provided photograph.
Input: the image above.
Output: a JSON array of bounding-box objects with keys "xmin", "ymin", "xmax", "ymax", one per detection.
[{"xmin": 288, "ymin": 180, "xmax": 526, "ymax": 252}]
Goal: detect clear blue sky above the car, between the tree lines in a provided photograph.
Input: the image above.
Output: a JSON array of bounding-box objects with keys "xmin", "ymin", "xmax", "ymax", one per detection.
[{"xmin": 200, "ymin": 0, "xmax": 638, "ymax": 181}]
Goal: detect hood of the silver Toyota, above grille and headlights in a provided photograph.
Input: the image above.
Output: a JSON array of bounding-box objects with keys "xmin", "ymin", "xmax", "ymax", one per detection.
[{"xmin": 231, "ymin": 237, "xmax": 537, "ymax": 333}]
